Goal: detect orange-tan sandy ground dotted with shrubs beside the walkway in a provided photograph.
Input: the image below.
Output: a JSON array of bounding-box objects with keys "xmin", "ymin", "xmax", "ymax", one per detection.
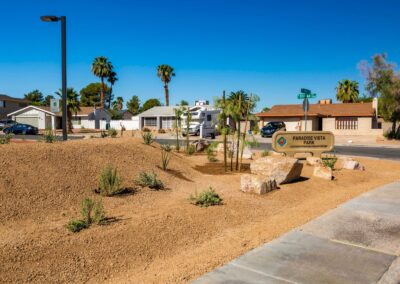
[{"xmin": 0, "ymin": 137, "xmax": 400, "ymax": 283}]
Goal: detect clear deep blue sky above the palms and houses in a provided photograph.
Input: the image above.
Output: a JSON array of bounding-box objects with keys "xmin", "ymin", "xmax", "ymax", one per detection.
[{"xmin": 0, "ymin": 0, "xmax": 400, "ymax": 108}]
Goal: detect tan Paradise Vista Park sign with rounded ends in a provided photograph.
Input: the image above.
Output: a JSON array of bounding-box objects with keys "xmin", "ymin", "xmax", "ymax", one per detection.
[{"xmin": 272, "ymin": 131, "xmax": 335, "ymax": 157}]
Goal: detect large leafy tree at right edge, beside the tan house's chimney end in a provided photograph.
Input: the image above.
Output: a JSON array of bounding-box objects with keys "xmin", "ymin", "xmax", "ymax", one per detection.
[{"xmin": 359, "ymin": 54, "xmax": 400, "ymax": 134}]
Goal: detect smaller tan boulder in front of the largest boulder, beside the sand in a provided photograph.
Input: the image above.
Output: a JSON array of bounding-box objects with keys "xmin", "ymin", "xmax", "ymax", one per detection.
[{"xmin": 240, "ymin": 174, "xmax": 278, "ymax": 194}]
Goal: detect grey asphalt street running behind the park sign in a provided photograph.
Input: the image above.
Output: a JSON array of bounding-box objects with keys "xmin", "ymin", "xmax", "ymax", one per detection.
[{"xmin": 156, "ymin": 139, "xmax": 400, "ymax": 161}]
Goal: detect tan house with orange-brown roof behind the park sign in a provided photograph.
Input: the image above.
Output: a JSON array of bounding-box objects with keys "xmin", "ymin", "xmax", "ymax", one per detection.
[{"xmin": 256, "ymin": 99, "xmax": 383, "ymax": 135}]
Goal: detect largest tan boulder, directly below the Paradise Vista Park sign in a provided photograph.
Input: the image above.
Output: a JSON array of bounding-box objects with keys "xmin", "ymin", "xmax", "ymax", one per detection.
[{"xmin": 250, "ymin": 156, "xmax": 303, "ymax": 185}]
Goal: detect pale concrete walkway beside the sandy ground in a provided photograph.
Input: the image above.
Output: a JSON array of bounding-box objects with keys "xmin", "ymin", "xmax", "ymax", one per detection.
[{"xmin": 194, "ymin": 182, "xmax": 400, "ymax": 284}]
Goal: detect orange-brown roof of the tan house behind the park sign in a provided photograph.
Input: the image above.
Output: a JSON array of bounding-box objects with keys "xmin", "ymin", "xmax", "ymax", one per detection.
[{"xmin": 256, "ymin": 103, "xmax": 375, "ymax": 117}]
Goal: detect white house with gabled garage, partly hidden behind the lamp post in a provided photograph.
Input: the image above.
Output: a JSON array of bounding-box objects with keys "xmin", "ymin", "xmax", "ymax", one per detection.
[{"xmin": 7, "ymin": 105, "xmax": 111, "ymax": 129}]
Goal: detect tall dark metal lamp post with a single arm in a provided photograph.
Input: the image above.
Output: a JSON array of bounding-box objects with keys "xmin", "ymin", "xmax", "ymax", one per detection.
[{"xmin": 40, "ymin": 16, "xmax": 68, "ymax": 140}]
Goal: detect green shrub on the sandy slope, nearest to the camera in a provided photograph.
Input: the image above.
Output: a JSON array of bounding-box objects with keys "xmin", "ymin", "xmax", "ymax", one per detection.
[{"xmin": 67, "ymin": 198, "xmax": 106, "ymax": 233}]
